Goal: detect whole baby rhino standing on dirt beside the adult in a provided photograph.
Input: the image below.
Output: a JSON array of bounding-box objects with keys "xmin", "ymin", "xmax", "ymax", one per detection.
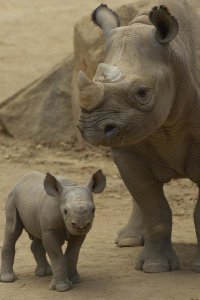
[{"xmin": 0, "ymin": 170, "xmax": 106, "ymax": 291}]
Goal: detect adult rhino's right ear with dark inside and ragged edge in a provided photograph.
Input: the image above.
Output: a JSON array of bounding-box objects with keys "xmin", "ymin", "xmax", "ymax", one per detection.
[{"xmin": 149, "ymin": 5, "xmax": 179, "ymax": 44}]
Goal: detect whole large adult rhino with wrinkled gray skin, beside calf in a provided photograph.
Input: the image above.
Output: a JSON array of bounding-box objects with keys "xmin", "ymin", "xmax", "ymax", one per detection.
[{"xmin": 78, "ymin": 0, "xmax": 200, "ymax": 273}]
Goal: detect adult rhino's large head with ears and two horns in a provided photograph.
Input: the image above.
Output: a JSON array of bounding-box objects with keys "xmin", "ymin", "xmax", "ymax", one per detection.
[{"xmin": 78, "ymin": 4, "xmax": 178, "ymax": 147}]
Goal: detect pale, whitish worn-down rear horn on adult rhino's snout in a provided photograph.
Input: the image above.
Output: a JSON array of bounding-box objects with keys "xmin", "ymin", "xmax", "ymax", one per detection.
[{"xmin": 94, "ymin": 63, "xmax": 122, "ymax": 82}]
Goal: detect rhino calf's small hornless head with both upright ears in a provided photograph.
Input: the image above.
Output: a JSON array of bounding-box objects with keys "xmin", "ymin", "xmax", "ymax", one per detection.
[{"xmin": 44, "ymin": 170, "xmax": 106, "ymax": 235}]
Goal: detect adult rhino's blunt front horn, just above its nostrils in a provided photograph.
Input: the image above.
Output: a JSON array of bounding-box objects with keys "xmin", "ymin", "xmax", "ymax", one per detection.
[{"xmin": 78, "ymin": 71, "xmax": 104, "ymax": 111}]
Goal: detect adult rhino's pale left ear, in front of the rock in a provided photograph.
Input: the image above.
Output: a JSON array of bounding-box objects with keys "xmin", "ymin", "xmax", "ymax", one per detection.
[{"xmin": 91, "ymin": 4, "xmax": 120, "ymax": 37}]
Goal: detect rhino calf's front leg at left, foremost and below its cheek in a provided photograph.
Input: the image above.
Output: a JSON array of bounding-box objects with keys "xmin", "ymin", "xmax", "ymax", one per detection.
[{"xmin": 42, "ymin": 230, "xmax": 72, "ymax": 292}]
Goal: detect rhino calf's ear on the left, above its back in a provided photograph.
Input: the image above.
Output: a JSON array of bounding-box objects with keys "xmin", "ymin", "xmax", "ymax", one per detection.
[{"xmin": 44, "ymin": 173, "xmax": 62, "ymax": 197}]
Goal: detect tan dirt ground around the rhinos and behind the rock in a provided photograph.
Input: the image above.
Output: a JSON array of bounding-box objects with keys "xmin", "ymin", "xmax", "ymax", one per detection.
[{"xmin": 0, "ymin": 0, "xmax": 200, "ymax": 300}]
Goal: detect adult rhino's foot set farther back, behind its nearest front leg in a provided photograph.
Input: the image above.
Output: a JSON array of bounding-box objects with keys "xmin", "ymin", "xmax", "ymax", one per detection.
[{"xmin": 115, "ymin": 226, "xmax": 144, "ymax": 247}]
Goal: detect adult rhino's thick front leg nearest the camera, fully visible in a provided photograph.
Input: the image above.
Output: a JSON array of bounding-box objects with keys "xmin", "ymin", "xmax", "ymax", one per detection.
[{"xmin": 113, "ymin": 149, "xmax": 179, "ymax": 273}]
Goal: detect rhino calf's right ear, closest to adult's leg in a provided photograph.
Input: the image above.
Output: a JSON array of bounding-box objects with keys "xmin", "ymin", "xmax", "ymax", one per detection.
[{"xmin": 87, "ymin": 170, "xmax": 106, "ymax": 194}]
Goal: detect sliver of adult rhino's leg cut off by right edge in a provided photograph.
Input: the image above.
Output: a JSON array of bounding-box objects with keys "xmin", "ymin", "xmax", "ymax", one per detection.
[{"xmin": 192, "ymin": 193, "xmax": 200, "ymax": 273}]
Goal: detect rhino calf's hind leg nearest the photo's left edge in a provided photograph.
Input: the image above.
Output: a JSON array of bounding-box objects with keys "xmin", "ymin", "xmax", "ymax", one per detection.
[{"xmin": 0, "ymin": 194, "xmax": 23, "ymax": 282}]
